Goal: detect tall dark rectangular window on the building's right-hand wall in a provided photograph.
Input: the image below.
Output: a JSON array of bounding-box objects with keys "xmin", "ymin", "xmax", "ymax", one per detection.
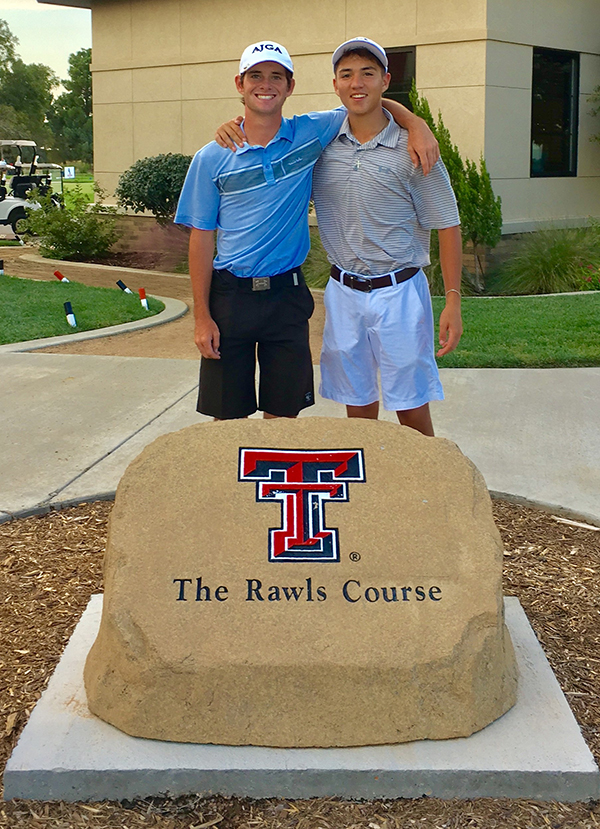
[{"xmin": 531, "ymin": 49, "xmax": 579, "ymax": 177}]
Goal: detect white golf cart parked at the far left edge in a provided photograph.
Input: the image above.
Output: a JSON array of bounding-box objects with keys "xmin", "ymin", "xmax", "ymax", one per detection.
[{"xmin": 0, "ymin": 139, "xmax": 63, "ymax": 231}]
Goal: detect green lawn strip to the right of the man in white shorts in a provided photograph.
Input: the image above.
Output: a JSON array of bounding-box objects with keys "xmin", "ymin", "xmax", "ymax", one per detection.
[{"xmin": 433, "ymin": 292, "xmax": 600, "ymax": 368}]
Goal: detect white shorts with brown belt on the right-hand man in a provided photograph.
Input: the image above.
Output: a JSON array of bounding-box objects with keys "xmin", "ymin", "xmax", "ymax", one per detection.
[{"xmin": 319, "ymin": 270, "xmax": 444, "ymax": 411}]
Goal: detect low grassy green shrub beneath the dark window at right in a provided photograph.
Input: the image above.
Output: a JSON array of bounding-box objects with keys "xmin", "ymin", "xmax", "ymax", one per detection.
[{"xmin": 498, "ymin": 225, "xmax": 600, "ymax": 294}]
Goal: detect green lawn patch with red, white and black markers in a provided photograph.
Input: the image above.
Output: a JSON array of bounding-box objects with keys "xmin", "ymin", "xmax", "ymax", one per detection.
[{"xmin": 0, "ymin": 276, "xmax": 164, "ymax": 345}]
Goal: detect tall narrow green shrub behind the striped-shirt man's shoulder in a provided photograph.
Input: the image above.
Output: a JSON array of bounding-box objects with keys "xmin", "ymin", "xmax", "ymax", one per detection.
[{"xmin": 410, "ymin": 81, "xmax": 502, "ymax": 291}]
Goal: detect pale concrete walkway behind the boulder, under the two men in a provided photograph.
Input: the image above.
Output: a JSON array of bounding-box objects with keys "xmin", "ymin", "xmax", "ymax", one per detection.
[{"xmin": 0, "ymin": 353, "xmax": 600, "ymax": 525}]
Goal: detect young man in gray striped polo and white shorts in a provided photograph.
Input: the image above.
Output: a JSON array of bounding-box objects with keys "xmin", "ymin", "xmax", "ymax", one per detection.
[{"xmin": 313, "ymin": 38, "xmax": 462, "ymax": 435}]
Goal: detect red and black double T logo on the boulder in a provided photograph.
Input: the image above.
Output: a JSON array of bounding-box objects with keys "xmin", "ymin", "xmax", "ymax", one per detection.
[{"xmin": 239, "ymin": 449, "xmax": 365, "ymax": 561}]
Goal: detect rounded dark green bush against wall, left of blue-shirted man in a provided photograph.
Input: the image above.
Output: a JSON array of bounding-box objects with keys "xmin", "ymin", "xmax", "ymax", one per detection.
[{"xmin": 115, "ymin": 153, "xmax": 192, "ymax": 224}]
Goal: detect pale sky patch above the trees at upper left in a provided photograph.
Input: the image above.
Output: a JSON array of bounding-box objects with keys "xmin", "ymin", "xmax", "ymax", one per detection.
[{"xmin": 0, "ymin": 0, "xmax": 92, "ymax": 78}]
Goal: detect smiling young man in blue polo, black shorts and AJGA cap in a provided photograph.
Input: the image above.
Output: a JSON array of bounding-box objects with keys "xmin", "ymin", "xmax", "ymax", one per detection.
[{"xmin": 175, "ymin": 41, "xmax": 431, "ymax": 419}]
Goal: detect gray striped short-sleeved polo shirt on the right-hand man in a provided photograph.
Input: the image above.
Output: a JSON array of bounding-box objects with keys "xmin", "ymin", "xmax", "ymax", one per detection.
[{"xmin": 313, "ymin": 110, "xmax": 460, "ymax": 276}]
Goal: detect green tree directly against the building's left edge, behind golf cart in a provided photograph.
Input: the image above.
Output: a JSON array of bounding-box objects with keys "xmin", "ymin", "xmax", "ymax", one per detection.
[{"xmin": 48, "ymin": 49, "xmax": 93, "ymax": 164}]
